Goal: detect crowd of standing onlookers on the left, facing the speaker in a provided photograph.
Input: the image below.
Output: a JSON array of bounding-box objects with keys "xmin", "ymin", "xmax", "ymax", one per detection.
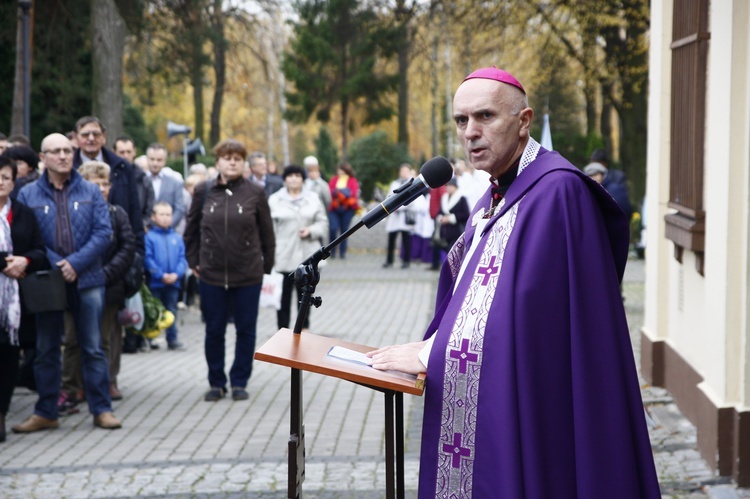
[{"xmin": 0, "ymin": 123, "xmax": 428, "ymax": 441}]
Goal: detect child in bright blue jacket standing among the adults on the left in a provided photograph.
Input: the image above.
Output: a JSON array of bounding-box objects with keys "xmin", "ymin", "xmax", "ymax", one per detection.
[{"xmin": 146, "ymin": 201, "xmax": 187, "ymax": 350}]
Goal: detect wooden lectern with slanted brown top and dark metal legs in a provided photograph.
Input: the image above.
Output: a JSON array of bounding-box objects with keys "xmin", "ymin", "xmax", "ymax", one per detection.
[{"xmin": 255, "ymin": 329, "xmax": 425, "ymax": 499}]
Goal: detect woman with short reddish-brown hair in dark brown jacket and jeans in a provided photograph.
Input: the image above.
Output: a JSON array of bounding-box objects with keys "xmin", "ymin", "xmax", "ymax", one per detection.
[{"xmin": 184, "ymin": 139, "xmax": 275, "ymax": 402}]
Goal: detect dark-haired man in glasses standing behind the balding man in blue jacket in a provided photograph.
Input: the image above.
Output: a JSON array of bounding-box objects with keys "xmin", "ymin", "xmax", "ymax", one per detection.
[{"xmin": 73, "ymin": 116, "xmax": 144, "ymax": 254}]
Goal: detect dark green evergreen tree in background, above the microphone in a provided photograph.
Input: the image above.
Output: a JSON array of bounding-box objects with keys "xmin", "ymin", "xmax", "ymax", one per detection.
[{"xmin": 282, "ymin": 0, "xmax": 398, "ymax": 157}]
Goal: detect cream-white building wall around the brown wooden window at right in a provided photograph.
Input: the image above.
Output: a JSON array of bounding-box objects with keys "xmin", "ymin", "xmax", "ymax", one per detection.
[{"xmin": 643, "ymin": 0, "xmax": 750, "ymax": 409}]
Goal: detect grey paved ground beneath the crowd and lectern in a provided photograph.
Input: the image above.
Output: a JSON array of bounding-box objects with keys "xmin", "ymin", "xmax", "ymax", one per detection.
[{"xmin": 0, "ymin": 220, "xmax": 750, "ymax": 499}]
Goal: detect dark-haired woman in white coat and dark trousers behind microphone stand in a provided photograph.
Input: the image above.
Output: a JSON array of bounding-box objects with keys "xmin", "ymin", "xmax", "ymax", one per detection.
[{"xmin": 268, "ymin": 165, "xmax": 328, "ymax": 329}]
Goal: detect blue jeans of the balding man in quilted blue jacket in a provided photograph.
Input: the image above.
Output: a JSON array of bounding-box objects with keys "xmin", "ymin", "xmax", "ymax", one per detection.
[{"xmin": 34, "ymin": 284, "xmax": 112, "ymax": 419}]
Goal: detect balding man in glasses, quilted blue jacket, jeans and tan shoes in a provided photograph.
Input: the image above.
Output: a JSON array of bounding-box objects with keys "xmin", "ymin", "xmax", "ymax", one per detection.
[{"xmin": 13, "ymin": 133, "xmax": 121, "ymax": 433}]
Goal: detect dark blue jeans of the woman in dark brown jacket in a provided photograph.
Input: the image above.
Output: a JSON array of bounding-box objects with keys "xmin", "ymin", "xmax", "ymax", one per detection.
[{"xmin": 200, "ymin": 281, "xmax": 261, "ymax": 388}]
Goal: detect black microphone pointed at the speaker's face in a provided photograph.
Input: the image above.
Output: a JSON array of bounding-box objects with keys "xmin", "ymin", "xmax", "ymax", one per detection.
[{"xmin": 361, "ymin": 156, "xmax": 453, "ymax": 229}]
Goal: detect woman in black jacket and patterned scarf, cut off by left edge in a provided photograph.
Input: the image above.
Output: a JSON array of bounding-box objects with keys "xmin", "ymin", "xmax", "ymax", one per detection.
[{"xmin": 0, "ymin": 155, "xmax": 49, "ymax": 442}]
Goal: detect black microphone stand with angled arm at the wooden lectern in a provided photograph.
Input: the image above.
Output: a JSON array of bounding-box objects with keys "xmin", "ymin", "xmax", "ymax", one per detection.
[{"xmin": 287, "ymin": 220, "xmax": 364, "ymax": 499}]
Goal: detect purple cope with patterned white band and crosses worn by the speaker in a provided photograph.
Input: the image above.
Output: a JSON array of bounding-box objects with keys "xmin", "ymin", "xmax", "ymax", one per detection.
[{"xmin": 419, "ymin": 146, "xmax": 661, "ymax": 499}]
